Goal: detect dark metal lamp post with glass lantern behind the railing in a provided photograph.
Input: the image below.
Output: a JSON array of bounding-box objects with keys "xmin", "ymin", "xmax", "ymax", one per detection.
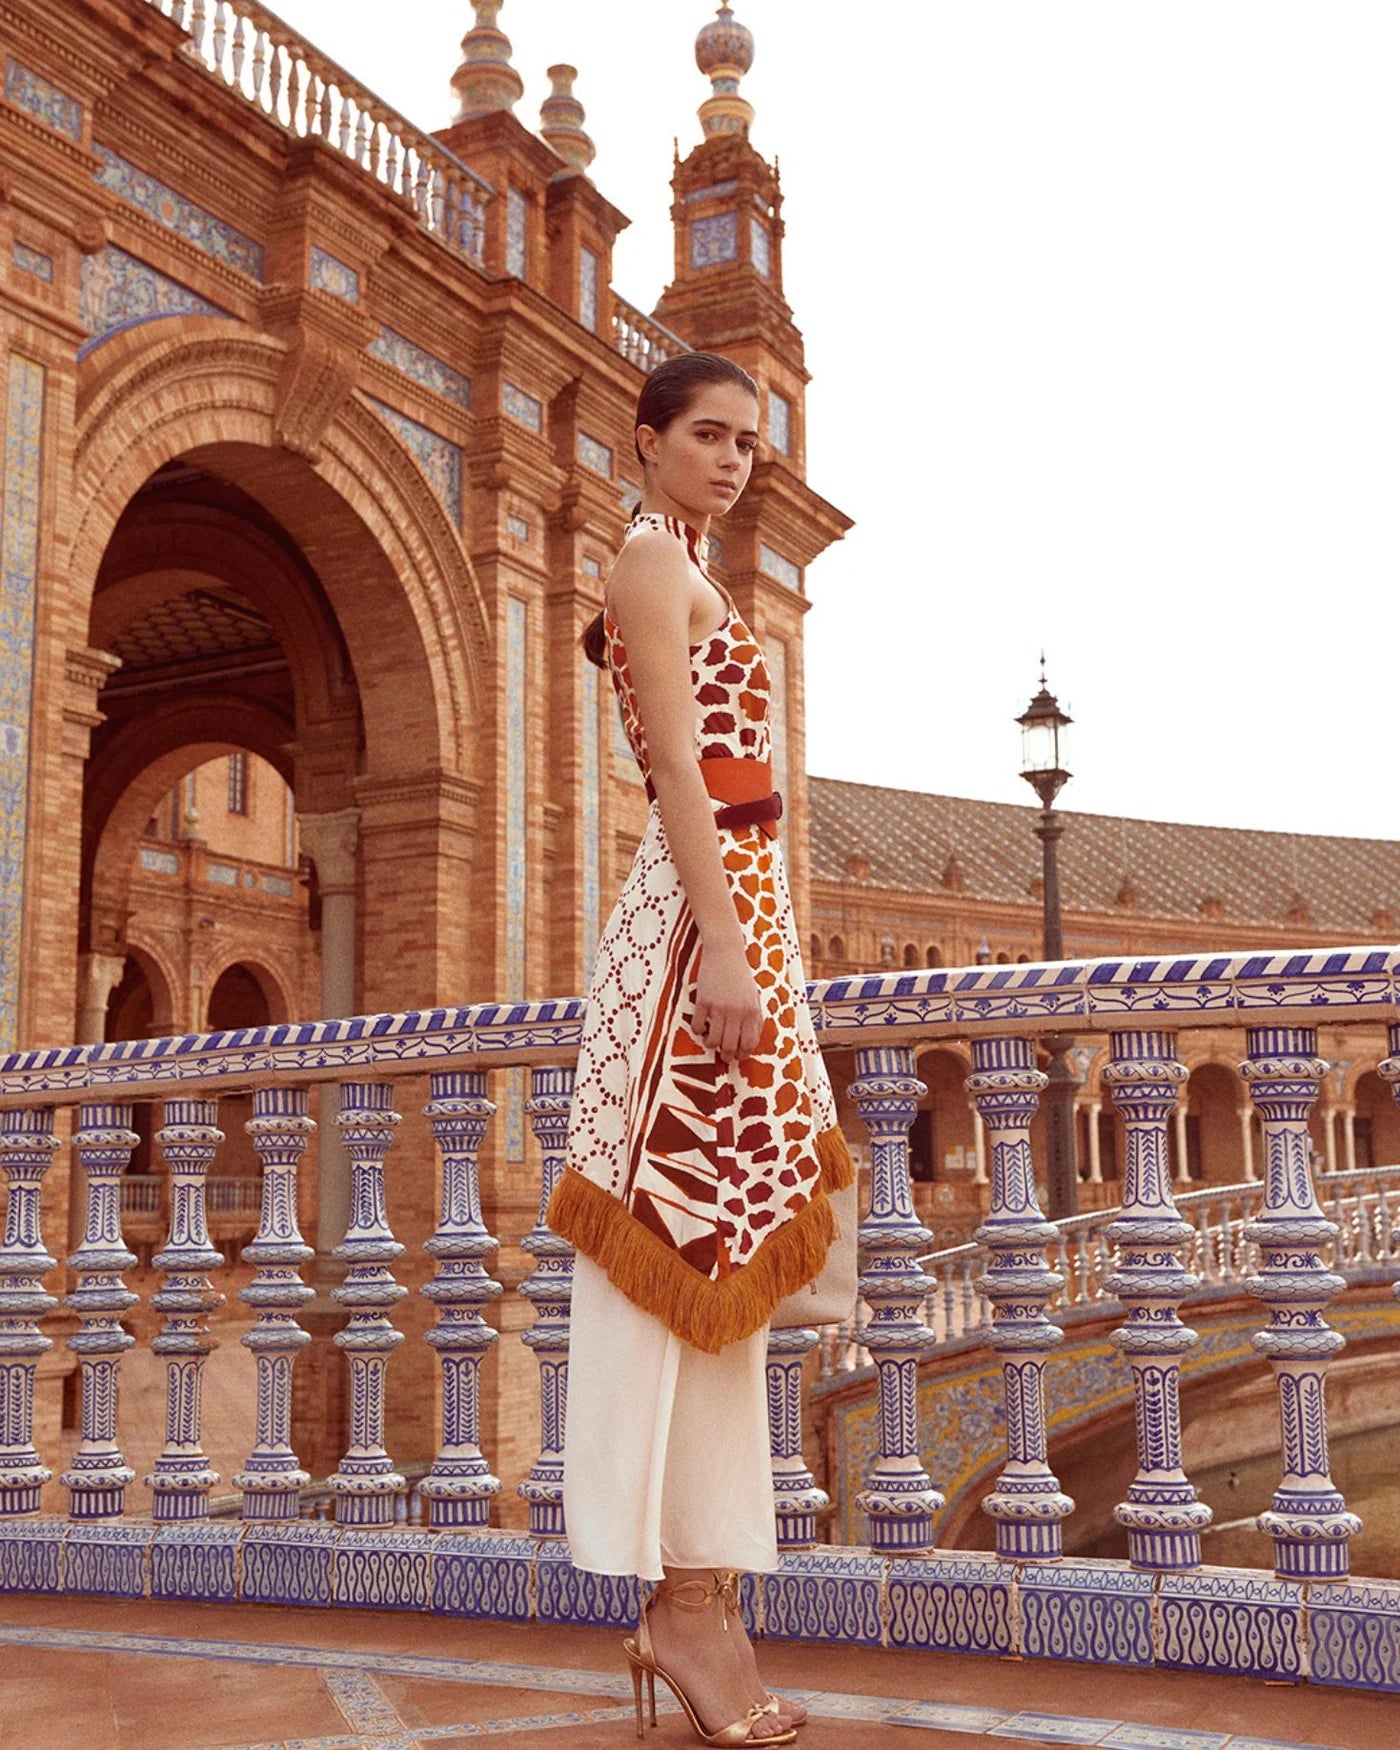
[{"xmin": 1017, "ymin": 655, "xmax": 1080, "ymax": 1222}]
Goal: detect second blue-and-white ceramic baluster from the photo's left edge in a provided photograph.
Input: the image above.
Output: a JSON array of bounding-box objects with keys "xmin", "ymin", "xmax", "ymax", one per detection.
[{"xmin": 60, "ymin": 1101, "xmax": 140, "ymax": 1519}]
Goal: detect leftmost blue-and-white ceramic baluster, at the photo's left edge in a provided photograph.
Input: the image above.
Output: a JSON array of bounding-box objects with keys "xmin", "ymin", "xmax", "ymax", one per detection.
[{"xmin": 0, "ymin": 1106, "xmax": 58, "ymax": 1519}]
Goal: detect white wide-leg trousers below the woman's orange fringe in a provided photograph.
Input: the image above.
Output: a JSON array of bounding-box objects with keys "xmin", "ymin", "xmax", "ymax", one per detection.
[{"xmin": 564, "ymin": 1257, "xmax": 777, "ymax": 1580}]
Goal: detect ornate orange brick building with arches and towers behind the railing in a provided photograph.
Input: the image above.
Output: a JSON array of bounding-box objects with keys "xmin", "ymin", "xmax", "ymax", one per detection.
[{"xmin": 0, "ymin": 0, "xmax": 1400, "ymax": 1523}]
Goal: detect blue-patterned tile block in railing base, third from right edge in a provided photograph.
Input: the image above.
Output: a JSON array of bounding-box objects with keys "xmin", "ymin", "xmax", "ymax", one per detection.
[{"xmin": 1020, "ymin": 1558, "xmax": 1155, "ymax": 1666}]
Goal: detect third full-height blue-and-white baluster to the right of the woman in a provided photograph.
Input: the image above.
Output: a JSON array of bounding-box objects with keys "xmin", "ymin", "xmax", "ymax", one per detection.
[{"xmin": 1103, "ymin": 1031, "xmax": 1211, "ymax": 1570}]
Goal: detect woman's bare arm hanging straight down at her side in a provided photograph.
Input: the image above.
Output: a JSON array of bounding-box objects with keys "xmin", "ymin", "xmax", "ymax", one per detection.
[{"xmin": 607, "ymin": 530, "xmax": 763, "ymax": 1057}]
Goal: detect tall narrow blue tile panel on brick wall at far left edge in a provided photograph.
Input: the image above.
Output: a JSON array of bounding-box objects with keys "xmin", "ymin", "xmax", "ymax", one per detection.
[{"xmin": 0, "ymin": 352, "xmax": 46, "ymax": 1052}]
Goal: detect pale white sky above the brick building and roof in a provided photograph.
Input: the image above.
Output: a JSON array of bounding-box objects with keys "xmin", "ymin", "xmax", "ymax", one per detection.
[{"xmin": 278, "ymin": 0, "xmax": 1400, "ymax": 840}]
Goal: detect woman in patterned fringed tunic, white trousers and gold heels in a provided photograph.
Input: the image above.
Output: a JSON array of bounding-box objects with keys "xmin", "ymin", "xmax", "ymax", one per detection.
[{"xmin": 550, "ymin": 354, "xmax": 852, "ymax": 1745}]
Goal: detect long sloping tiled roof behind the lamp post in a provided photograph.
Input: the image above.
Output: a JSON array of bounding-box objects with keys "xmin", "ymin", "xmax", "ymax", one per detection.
[{"xmin": 809, "ymin": 777, "xmax": 1400, "ymax": 942}]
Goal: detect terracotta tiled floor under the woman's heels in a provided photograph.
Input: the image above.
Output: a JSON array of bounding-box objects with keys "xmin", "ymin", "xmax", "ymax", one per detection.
[{"xmin": 0, "ymin": 1598, "xmax": 1400, "ymax": 1750}]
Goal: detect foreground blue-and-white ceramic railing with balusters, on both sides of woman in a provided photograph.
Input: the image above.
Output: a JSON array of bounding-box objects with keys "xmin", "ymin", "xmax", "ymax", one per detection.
[{"xmin": 0, "ymin": 949, "xmax": 1400, "ymax": 1689}]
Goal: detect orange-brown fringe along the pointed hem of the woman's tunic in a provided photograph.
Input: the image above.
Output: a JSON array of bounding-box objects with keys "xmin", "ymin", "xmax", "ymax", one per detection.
[{"xmin": 546, "ymin": 1124, "xmax": 856, "ymax": 1355}]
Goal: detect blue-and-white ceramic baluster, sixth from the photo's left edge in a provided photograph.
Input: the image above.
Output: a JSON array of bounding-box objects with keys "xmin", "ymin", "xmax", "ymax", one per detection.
[{"xmin": 420, "ymin": 1069, "xmax": 501, "ymax": 1531}]
